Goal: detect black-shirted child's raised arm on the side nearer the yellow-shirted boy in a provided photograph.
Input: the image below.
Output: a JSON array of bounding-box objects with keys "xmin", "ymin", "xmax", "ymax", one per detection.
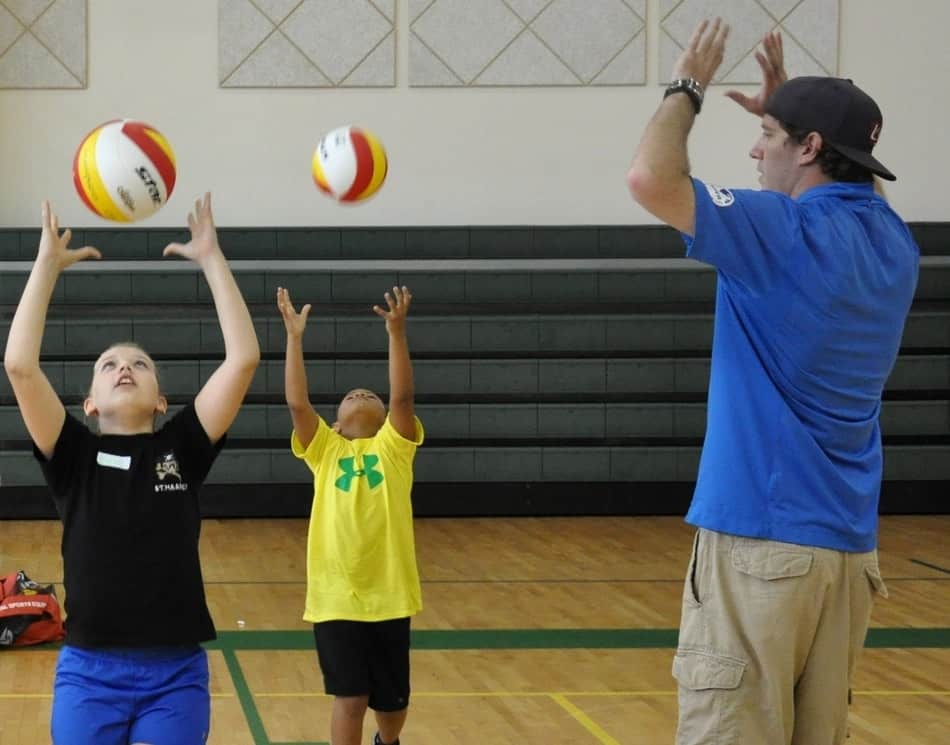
[{"xmin": 163, "ymin": 194, "xmax": 261, "ymax": 442}]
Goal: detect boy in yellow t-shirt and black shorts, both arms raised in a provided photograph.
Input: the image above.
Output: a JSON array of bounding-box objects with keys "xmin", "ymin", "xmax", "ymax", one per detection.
[{"xmin": 277, "ymin": 287, "xmax": 424, "ymax": 745}]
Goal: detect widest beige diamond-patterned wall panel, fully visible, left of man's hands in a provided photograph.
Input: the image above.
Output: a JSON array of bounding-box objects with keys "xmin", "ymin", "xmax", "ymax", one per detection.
[{"xmin": 409, "ymin": 0, "xmax": 646, "ymax": 86}]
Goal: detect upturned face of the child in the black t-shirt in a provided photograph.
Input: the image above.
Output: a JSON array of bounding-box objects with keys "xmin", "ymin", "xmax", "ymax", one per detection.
[{"xmin": 83, "ymin": 344, "xmax": 168, "ymax": 424}]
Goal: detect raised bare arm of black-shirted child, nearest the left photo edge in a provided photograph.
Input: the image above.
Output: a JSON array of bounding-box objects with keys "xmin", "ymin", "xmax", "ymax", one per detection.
[{"xmin": 3, "ymin": 201, "xmax": 101, "ymax": 460}]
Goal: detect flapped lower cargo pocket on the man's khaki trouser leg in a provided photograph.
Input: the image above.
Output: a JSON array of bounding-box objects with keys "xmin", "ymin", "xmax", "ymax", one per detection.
[{"xmin": 673, "ymin": 649, "xmax": 746, "ymax": 745}]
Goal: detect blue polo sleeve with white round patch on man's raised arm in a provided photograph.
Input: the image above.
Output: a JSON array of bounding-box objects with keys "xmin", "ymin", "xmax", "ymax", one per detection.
[{"xmin": 683, "ymin": 179, "xmax": 801, "ymax": 291}]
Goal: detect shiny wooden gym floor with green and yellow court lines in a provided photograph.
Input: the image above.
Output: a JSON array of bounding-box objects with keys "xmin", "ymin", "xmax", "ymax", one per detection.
[{"xmin": 0, "ymin": 516, "xmax": 950, "ymax": 745}]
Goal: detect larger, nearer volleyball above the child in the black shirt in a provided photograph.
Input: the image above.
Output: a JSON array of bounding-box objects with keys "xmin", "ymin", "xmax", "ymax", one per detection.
[{"xmin": 73, "ymin": 119, "xmax": 175, "ymax": 222}]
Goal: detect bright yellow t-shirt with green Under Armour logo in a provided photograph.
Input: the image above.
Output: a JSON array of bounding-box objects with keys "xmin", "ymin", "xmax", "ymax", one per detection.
[{"xmin": 290, "ymin": 417, "xmax": 425, "ymax": 623}]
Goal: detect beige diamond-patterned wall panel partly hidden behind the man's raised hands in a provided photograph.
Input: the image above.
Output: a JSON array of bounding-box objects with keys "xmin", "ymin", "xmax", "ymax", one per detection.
[{"xmin": 660, "ymin": 0, "xmax": 840, "ymax": 85}]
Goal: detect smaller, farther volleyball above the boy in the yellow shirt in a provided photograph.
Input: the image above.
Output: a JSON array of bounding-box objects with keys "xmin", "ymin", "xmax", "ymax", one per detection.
[{"xmin": 313, "ymin": 127, "xmax": 389, "ymax": 202}]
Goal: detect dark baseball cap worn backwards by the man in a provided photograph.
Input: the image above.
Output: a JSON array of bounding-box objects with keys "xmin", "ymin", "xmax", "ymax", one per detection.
[{"xmin": 765, "ymin": 76, "xmax": 897, "ymax": 181}]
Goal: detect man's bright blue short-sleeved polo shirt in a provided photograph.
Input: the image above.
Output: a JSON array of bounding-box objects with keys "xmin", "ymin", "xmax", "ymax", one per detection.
[{"xmin": 684, "ymin": 179, "xmax": 919, "ymax": 552}]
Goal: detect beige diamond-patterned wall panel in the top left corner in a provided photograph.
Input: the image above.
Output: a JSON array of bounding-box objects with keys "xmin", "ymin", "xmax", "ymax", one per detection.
[{"xmin": 0, "ymin": 0, "xmax": 86, "ymax": 88}]
